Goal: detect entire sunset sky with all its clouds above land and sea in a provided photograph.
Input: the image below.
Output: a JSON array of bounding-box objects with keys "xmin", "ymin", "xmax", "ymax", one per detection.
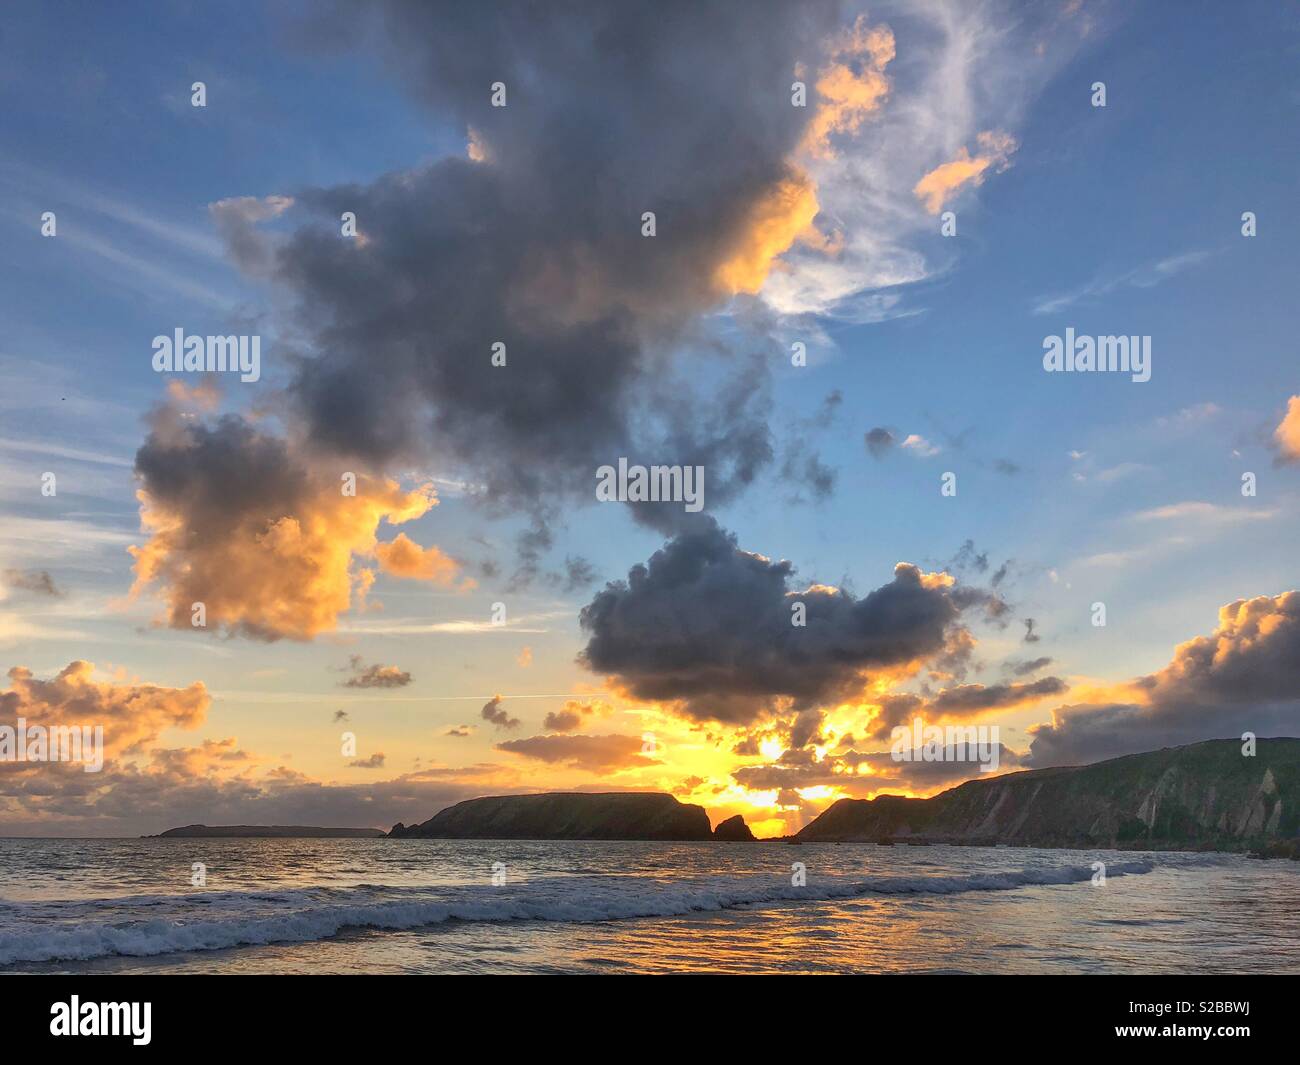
[{"xmin": 0, "ymin": 0, "xmax": 1300, "ymax": 836}]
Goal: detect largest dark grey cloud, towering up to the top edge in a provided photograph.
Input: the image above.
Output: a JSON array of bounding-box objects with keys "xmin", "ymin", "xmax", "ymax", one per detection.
[{"xmin": 250, "ymin": 0, "xmax": 841, "ymax": 540}]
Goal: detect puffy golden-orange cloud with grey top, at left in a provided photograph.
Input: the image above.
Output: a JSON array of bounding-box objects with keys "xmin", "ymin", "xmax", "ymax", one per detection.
[{"xmin": 130, "ymin": 392, "xmax": 452, "ymax": 641}]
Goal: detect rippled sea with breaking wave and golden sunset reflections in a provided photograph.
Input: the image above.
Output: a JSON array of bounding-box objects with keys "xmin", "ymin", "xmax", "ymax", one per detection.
[{"xmin": 0, "ymin": 839, "xmax": 1300, "ymax": 974}]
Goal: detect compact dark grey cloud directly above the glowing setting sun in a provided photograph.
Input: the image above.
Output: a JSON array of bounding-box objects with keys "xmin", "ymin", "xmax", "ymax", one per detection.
[{"xmin": 580, "ymin": 520, "xmax": 991, "ymax": 724}]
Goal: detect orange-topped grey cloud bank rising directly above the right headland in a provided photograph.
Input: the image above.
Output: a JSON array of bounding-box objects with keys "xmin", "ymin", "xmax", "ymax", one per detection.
[{"xmin": 1027, "ymin": 592, "xmax": 1300, "ymax": 766}]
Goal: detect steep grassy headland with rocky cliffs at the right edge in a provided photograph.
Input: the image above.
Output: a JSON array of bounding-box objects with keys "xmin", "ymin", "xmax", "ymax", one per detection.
[{"xmin": 796, "ymin": 739, "xmax": 1300, "ymax": 850}]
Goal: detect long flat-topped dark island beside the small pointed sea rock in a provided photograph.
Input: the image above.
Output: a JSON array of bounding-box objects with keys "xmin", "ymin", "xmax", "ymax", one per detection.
[{"xmin": 389, "ymin": 792, "xmax": 712, "ymax": 840}]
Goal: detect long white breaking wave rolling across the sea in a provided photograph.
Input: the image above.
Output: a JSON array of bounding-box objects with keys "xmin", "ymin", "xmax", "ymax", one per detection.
[{"xmin": 0, "ymin": 861, "xmax": 1154, "ymax": 965}]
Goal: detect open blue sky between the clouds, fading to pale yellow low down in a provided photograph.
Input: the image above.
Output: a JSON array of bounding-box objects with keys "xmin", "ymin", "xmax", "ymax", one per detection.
[{"xmin": 0, "ymin": 3, "xmax": 1300, "ymax": 842}]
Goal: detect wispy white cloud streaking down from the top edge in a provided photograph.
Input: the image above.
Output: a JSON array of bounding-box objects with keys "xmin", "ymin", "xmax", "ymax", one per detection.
[{"xmin": 761, "ymin": 4, "xmax": 1082, "ymax": 322}]
